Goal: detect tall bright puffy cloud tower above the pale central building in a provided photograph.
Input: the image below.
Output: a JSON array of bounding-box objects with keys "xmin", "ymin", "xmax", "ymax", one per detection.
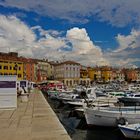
[{"xmin": 66, "ymin": 27, "xmax": 108, "ymax": 65}]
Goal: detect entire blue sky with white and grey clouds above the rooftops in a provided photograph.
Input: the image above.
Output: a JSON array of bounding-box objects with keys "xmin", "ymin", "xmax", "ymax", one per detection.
[{"xmin": 0, "ymin": 0, "xmax": 140, "ymax": 67}]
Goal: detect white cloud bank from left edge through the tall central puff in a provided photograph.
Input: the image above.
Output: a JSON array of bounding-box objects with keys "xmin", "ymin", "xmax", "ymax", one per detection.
[{"xmin": 0, "ymin": 15, "xmax": 108, "ymax": 65}]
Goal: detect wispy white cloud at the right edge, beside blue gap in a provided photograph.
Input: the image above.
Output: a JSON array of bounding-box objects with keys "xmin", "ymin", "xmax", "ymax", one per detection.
[{"xmin": 104, "ymin": 29, "xmax": 140, "ymax": 66}]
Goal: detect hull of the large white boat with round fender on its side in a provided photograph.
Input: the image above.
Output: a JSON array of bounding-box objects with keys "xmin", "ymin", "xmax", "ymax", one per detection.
[{"xmin": 84, "ymin": 108, "xmax": 140, "ymax": 127}]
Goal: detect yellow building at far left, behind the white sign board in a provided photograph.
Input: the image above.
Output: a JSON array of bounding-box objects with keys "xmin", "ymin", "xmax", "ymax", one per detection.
[{"xmin": 0, "ymin": 53, "xmax": 24, "ymax": 80}]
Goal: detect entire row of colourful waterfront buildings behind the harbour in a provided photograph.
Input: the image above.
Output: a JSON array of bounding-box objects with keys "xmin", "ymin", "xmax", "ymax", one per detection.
[{"xmin": 0, "ymin": 52, "xmax": 140, "ymax": 86}]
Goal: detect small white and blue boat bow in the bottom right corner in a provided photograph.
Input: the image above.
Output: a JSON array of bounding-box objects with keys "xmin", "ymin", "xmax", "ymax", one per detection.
[{"xmin": 118, "ymin": 123, "xmax": 140, "ymax": 139}]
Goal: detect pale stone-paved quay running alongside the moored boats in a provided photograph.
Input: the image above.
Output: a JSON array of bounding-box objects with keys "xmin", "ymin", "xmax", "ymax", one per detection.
[{"xmin": 0, "ymin": 90, "xmax": 71, "ymax": 140}]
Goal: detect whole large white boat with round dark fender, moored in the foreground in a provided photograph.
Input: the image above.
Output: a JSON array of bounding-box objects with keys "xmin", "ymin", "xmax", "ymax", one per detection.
[{"xmin": 84, "ymin": 106, "xmax": 140, "ymax": 127}]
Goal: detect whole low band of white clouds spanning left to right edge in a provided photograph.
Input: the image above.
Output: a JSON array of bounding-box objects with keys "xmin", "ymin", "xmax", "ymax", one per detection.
[{"xmin": 0, "ymin": 15, "xmax": 140, "ymax": 66}]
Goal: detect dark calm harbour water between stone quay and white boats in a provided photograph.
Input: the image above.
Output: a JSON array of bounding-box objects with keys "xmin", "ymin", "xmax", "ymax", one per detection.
[{"xmin": 44, "ymin": 94, "xmax": 128, "ymax": 140}]
